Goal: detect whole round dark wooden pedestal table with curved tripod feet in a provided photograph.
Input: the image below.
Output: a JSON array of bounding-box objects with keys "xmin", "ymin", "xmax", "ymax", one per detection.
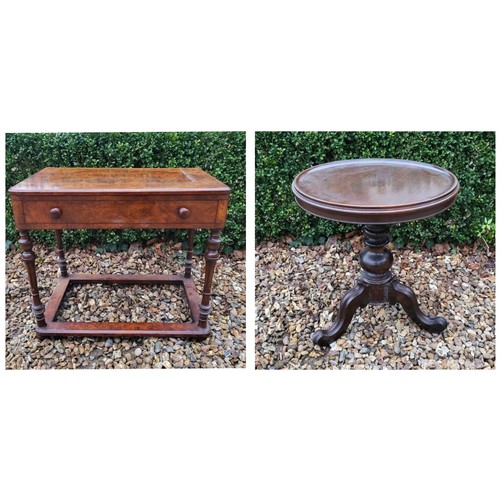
[{"xmin": 292, "ymin": 159, "xmax": 460, "ymax": 346}]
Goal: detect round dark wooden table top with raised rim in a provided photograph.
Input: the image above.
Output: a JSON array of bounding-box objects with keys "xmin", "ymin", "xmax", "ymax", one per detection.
[{"xmin": 292, "ymin": 158, "xmax": 460, "ymax": 224}]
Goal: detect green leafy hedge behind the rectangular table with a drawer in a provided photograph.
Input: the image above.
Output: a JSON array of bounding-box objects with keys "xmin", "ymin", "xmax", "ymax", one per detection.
[{"xmin": 6, "ymin": 132, "xmax": 246, "ymax": 252}]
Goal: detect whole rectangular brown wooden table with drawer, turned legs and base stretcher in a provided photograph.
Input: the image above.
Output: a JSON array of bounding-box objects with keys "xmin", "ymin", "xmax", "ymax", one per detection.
[{"xmin": 9, "ymin": 167, "xmax": 230, "ymax": 338}]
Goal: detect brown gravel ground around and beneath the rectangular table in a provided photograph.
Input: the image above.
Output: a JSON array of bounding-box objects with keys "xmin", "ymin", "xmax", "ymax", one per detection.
[{"xmin": 5, "ymin": 243, "xmax": 246, "ymax": 369}]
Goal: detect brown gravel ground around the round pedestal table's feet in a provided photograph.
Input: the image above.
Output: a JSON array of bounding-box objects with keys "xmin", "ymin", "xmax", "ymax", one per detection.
[{"xmin": 256, "ymin": 236, "xmax": 495, "ymax": 369}]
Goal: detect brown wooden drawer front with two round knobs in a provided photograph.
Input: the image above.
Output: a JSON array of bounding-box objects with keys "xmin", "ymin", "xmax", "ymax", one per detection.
[{"xmin": 23, "ymin": 200, "xmax": 218, "ymax": 228}]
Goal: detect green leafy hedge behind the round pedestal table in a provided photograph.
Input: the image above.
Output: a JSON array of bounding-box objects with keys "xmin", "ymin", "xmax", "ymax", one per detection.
[{"xmin": 255, "ymin": 132, "xmax": 495, "ymax": 246}]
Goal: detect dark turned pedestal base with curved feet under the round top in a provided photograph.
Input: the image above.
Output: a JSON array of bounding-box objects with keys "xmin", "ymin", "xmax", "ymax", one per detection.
[{"xmin": 311, "ymin": 224, "xmax": 448, "ymax": 346}]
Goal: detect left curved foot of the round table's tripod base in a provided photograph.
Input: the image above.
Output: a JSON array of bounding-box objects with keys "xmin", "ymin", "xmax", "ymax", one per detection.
[{"xmin": 311, "ymin": 283, "xmax": 369, "ymax": 347}]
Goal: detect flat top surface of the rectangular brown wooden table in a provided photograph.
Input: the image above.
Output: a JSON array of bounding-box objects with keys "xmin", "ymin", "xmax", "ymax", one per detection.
[{"xmin": 9, "ymin": 167, "xmax": 230, "ymax": 195}]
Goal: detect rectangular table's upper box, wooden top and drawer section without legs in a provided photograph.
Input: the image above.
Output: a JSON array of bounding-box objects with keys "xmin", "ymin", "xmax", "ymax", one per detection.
[{"xmin": 9, "ymin": 167, "xmax": 231, "ymax": 229}]
